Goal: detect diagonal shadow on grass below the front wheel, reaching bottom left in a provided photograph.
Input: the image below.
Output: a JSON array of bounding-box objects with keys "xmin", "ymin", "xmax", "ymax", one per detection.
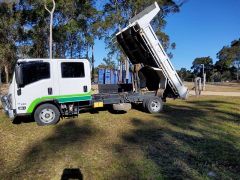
[{"xmin": 6, "ymin": 121, "xmax": 101, "ymax": 179}]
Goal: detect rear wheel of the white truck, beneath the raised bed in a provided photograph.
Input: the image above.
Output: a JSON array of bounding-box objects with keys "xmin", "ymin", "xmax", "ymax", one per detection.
[{"xmin": 145, "ymin": 96, "xmax": 163, "ymax": 114}]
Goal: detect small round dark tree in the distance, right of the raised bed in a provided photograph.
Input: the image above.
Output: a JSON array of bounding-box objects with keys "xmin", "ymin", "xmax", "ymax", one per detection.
[{"xmin": 191, "ymin": 56, "xmax": 213, "ymax": 80}]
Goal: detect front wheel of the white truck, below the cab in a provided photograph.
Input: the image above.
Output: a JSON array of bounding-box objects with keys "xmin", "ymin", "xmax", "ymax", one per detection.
[{"xmin": 34, "ymin": 104, "xmax": 60, "ymax": 126}]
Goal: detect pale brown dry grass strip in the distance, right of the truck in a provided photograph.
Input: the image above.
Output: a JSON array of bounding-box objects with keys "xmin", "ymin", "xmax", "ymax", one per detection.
[{"xmin": 184, "ymin": 82, "xmax": 240, "ymax": 92}]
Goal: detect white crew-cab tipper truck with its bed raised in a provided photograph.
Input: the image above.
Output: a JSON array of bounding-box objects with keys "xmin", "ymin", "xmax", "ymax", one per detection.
[{"xmin": 1, "ymin": 3, "xmax": 188, "ymax": 125}]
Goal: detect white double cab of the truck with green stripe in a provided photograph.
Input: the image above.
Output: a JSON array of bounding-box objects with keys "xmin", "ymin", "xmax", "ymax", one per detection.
[{"xmin": 2, "ymin": 59, "xmax": 91, "ymax": 122}]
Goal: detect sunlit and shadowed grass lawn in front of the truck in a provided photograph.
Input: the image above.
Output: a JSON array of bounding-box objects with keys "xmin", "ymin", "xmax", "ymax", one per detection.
[{"xmin": 0, "ymin": 96, "xmax": 240, "ymax": 179}]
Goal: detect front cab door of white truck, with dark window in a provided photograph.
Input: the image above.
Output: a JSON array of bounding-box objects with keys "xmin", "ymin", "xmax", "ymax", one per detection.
[{"xmin": 15, "ymin": 60, "xmax": 56, "ymax": 114}]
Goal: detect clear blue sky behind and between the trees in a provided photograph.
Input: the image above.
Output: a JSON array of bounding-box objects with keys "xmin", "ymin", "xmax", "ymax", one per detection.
[{"xmin": 95, "ymin": 0, "xmax": 240, "ymax": 69}]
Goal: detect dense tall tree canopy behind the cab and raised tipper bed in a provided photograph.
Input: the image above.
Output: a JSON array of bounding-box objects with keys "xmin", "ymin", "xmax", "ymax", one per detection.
[{"xmin": 0, "ymin": 0, "xmax": 182, "ymax": 83}]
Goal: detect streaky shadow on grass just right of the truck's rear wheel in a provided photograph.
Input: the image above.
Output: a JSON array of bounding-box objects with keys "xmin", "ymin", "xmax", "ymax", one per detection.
[{"xmin": 161, "ymin": 100, "xmax": 240, "ymax": 129}]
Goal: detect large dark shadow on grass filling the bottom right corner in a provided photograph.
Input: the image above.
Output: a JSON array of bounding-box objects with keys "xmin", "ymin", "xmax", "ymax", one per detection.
[{"xmin": 115, "ymin": 119, "xmax": 240, "ymax": 179}]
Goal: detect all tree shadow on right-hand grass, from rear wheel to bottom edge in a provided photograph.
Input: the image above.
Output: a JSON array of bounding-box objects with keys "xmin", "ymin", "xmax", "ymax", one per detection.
[{"xmin": 113, "ymin": 98, "xmax": 240, "ymax": 179}]
